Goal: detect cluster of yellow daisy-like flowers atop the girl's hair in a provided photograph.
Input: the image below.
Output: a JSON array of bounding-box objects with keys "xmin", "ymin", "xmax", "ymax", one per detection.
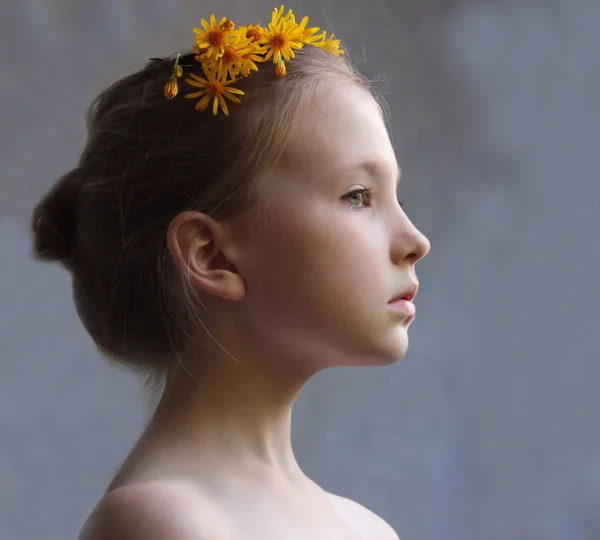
[{"xmin": 164, "ymin": 6, "xmax": 344, "ymax": 115}]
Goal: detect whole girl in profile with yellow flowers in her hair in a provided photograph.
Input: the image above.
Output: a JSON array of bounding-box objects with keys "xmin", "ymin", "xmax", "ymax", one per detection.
[{"xmin": 32, "ymin": 6, "xmax": 429, "ymax": 540}]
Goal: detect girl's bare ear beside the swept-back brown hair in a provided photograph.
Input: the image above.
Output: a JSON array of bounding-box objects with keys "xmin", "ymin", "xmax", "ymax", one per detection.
[{"xmin": 167, "ymin": 211, "xmax": 245, "ymax": 300}]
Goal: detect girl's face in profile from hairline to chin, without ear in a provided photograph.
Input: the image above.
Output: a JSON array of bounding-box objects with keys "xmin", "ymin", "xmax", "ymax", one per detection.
[{"xmin": 224, "ymin": 84, "xmax": 430, "ymax": 372}]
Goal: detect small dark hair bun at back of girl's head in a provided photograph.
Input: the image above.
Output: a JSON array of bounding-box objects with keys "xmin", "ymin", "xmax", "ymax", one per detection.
[{"xmin": 31, "ymin": 168, "xmax": 81, "ymax": 266}]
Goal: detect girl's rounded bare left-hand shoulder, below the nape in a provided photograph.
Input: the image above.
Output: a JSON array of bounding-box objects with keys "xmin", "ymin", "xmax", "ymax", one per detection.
[{"xmin": 78, "ymin": 482, "xmax": 226, "ymax": 540}]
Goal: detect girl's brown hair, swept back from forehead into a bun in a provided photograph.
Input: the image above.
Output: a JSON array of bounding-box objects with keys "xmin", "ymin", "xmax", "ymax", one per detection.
[{"xmin": 31, "ymin": 46, "xmax": 379, "ymax": 392}]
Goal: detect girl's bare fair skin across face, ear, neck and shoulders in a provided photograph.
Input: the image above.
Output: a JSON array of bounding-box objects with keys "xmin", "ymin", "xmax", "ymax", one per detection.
[{"xmin": 80, "ymin": 83, "xmax": 430, "ymax": 540}]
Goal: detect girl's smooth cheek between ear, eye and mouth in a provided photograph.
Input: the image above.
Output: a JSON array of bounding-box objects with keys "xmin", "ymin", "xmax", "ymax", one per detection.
[{"xmin": 246, "ymin": 209, "xmax": 385, "ymax": 324}]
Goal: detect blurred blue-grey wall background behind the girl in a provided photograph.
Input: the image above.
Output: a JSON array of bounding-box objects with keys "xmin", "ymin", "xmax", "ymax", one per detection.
[{"xmin": 0, "ymin": 0, "xmax": 600, "ymax": 540}]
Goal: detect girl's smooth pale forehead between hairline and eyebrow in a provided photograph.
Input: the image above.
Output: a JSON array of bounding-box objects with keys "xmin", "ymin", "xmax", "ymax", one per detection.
[{"xmin": 283, "ymin": 83, "xmax": 398, "ymax": 184}]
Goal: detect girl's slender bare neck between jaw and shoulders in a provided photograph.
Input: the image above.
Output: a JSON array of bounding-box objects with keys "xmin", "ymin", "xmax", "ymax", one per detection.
[{"xmin": 146, "ymin": 350, "xmax": 310, "ymax": 485}]
